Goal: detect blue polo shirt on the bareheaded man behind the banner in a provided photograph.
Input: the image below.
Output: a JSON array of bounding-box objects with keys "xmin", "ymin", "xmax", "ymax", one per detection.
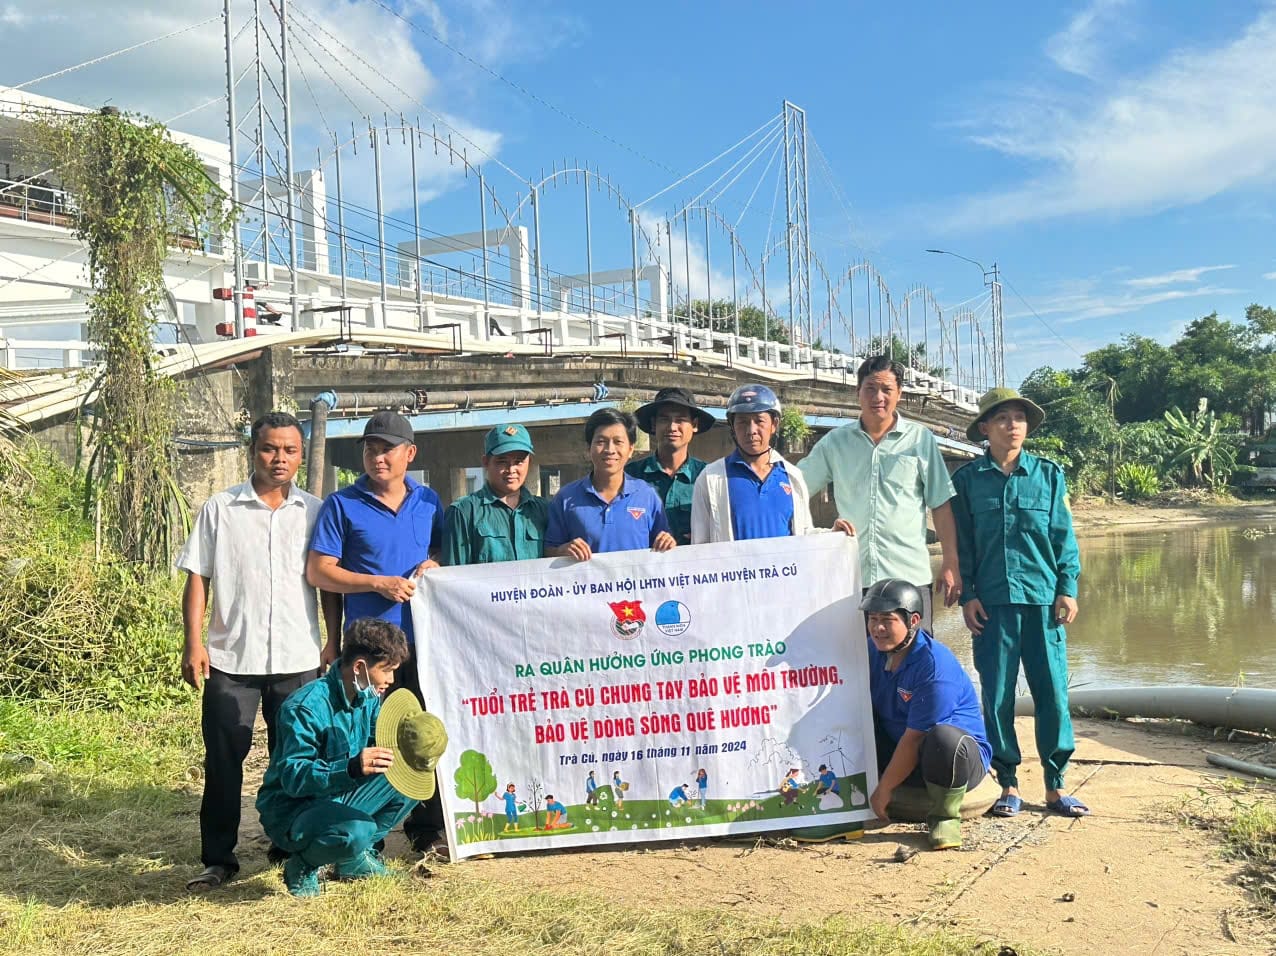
[{"xmin": 545, "ymin": 475, "xmax": 669, "ymax": 554}]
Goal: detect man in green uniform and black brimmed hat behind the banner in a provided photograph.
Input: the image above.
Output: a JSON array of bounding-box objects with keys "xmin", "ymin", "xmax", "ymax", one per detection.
[{"xmin": 625, "ymin": 388, "xmax": 713, "ymax": 545}]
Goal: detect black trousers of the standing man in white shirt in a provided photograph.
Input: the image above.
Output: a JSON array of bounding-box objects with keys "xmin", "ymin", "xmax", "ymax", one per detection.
[{"xmin": 199, "ymin": 669, "xmax": 319, "ymax": 873}]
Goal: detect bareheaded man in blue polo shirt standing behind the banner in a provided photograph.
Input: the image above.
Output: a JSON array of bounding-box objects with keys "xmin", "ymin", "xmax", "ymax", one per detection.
[{"xmin": 545, "ymin": 408, "xmax": 678, "ymax": 562}]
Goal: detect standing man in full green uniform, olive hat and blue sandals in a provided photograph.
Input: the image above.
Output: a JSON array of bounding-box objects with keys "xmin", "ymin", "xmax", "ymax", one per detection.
[{"xmin": 953, "ymin": 388, "xmax": 1090, "ymax": 817}]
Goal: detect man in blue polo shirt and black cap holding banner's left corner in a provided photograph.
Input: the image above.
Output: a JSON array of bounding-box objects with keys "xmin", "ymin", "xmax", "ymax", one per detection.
[{"xmin": 306, "ymin": 410, "xmax": 443, "ymax": 851}]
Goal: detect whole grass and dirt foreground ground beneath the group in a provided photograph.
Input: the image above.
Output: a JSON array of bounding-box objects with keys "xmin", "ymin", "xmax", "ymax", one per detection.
[{"xmin": 0, "ymin": 701, "xmax": 1276, "ymax": 956}]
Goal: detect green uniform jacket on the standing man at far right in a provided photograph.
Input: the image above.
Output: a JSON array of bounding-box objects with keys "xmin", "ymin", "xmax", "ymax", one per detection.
[{"xmin": 953, "ymin": 452, "xmax": 1081, "ymax": 606}]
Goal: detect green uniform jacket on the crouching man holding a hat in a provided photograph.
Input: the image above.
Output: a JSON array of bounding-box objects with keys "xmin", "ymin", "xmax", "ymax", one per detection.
[{"xmin": 256, "ymin": 661, "xmax": 382, "ymax": 842}]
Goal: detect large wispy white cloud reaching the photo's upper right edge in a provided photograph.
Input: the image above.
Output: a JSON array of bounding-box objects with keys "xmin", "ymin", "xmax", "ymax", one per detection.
[{"xmin": 940, "ymin": 8, "xmax": 1276, "ymax": 231}]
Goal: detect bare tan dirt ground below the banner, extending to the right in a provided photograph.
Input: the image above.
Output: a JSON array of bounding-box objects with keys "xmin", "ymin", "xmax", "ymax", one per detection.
[{"xmin": 234, "ymin": 719, "xmax": 1276, "ymax": 956}]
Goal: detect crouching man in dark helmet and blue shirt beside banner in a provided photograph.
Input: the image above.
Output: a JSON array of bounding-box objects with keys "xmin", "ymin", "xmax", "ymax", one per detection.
[{"xmin": 860, "ymin": 578, "xmax": 993, "ymax": 850}]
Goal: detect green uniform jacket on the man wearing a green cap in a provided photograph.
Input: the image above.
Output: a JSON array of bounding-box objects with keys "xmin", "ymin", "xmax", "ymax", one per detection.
[{"xmin": 439, "ymin": 485, "xmax": 549, "ymax": 567}]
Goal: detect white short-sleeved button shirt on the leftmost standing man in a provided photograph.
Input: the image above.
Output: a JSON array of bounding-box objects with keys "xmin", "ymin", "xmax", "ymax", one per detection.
[{"xmin": 176, "ymin": 481, "xmax": 322, "ymax": 675}]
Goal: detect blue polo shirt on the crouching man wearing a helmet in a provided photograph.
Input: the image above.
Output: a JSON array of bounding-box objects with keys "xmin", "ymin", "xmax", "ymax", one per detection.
[{"xmin": 869, "ymin": 631, "xmax": 993, "ymax": 770}]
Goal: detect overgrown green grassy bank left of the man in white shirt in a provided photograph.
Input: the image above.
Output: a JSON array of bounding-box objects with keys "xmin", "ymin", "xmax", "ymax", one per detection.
[{"xmin": 0, "ymin": 443, "xmax": 185, "ymax": 707}]
